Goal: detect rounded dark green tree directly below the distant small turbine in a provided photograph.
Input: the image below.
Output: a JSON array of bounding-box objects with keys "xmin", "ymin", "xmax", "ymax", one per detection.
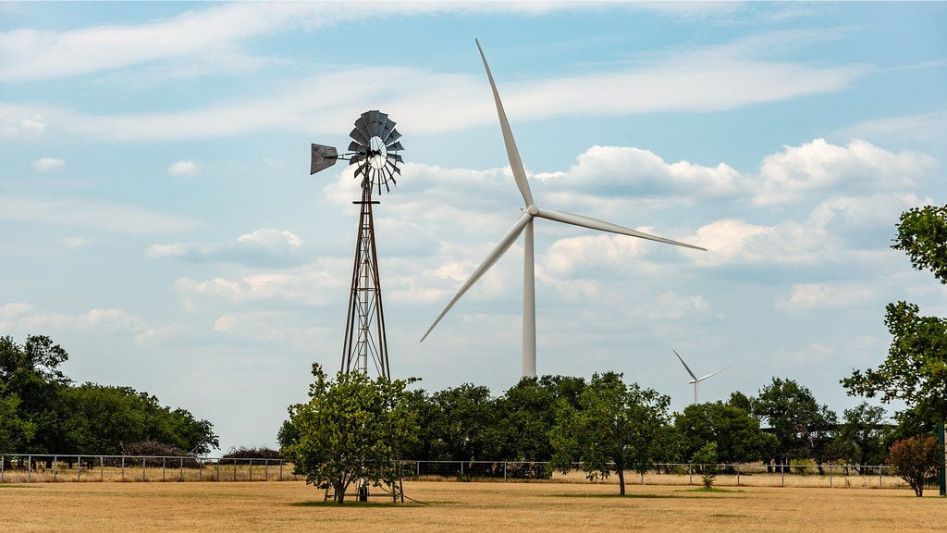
[{"xmin": 674, "ymin": 402, "xmax": 770, "ymax": 463}]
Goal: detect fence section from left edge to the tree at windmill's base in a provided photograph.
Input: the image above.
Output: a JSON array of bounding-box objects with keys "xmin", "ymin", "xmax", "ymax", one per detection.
[{"xmin": 0, "ymin": 454, "xmax": 299, "ymax": 483}]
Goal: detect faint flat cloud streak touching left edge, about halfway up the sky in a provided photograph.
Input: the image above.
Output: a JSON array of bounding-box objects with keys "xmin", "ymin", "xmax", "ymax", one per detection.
[{"xmin": 0, "ymin": 192, "xmax": 198, "ymax": 233}]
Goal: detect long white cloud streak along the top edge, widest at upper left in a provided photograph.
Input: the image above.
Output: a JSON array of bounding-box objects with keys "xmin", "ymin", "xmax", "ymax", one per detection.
[{"xmin": 0, "ymin": 2, "xmax": 732, "ymax": 81}]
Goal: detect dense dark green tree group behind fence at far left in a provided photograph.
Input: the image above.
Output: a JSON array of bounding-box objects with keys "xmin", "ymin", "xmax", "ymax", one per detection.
[{"xmin": 0, "ymin": 335, "xmax": 218, "ymax": 455}]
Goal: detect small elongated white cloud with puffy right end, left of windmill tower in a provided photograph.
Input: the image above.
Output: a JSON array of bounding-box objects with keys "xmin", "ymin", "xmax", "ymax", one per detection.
[{"xmin": 145, "ymin": 228, "xmax": 303, "ymax": 264}]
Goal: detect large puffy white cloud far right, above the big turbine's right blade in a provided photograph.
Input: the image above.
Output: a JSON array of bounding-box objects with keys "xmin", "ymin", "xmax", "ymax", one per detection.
[{"xmin": 753, "ymin": 139, "xmax": 936, "ymax": 205}]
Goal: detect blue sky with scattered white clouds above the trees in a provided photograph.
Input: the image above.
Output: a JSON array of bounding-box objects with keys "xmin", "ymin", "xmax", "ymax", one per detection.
[{"xmin": 0, "ymin": 2, "xmax": 947, "ymax": 450}]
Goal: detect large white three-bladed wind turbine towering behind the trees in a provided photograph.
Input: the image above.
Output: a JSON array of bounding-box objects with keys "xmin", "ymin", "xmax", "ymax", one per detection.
[{"xmin": 421, "ymin": 41, "xmax": 706, "ymax": 377}]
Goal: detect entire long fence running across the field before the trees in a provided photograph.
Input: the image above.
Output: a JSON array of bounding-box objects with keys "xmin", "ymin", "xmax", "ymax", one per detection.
[{"xmin": 0, "ymin": 454, "xmax": 907, "ymax": 488}]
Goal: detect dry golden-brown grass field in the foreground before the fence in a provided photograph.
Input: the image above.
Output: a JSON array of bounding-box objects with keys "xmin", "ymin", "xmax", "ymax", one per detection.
[{"xmin": 0, "ymin": 482, "xmax": 947, "ymax": 532}]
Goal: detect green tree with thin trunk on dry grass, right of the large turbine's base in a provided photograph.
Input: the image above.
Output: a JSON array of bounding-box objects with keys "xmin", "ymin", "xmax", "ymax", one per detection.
[{"xmin": 550, "ymin": 372, "xmax": 669, "ymax": 495}]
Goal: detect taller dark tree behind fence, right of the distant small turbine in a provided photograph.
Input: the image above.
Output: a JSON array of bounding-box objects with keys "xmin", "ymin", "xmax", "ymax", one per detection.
[{"xmin": 752, "ymin": 378, "xmax": 836, "ymax": 473}]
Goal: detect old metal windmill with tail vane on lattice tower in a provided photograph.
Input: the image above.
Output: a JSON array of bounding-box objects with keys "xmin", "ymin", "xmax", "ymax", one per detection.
[{"xmin": 309, "ymin": 110, "xmax": 404, "ymax": 379}]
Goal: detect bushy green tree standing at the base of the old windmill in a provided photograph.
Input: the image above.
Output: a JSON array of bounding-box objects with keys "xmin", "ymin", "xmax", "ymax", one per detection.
[{"xmin": 281, "ymin": 364, "xmax": 418, "ymax": 503}]
